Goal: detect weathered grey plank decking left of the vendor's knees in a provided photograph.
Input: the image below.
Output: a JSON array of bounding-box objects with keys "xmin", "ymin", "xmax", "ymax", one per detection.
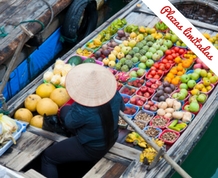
[{"xmin": 0, "ymin": 132, "xmax": 53, "ymax": 171}]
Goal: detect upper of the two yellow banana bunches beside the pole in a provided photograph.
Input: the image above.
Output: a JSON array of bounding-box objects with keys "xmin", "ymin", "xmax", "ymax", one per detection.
[{"xmin": 126, "ymin": 132, "xmax": 147, "ymax": 148}]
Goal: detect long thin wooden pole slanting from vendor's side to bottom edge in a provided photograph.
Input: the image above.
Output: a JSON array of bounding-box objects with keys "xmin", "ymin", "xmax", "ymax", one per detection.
[{"xmin": 119, "ymin": 111, "xmax": 191, "ymax": 178}]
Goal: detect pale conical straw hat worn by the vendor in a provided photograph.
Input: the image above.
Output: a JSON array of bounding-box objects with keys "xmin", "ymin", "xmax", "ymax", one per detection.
[{"xmin": 66, "ymin": 63, "xmax": 117, "ymax": 107}]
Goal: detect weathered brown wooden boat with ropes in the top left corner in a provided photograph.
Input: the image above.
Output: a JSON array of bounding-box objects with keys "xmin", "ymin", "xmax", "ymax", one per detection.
[{"xmin": 0, "ymin": 0, "xmax": 104, "ymax": 83}]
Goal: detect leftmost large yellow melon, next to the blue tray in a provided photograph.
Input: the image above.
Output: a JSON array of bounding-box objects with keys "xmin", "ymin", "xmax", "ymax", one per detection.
[{"xmin": 14, "ymin": 108, "xmax": 33, "ymax": 123}]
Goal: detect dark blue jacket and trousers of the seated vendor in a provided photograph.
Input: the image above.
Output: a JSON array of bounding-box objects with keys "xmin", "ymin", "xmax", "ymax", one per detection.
[{"xmin": 42, "ymin": 91, "xmax": 125, "ymax": 178}]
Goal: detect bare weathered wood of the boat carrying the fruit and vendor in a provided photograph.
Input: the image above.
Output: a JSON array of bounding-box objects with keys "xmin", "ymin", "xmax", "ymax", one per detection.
[{"xmin": 0, "ymin": 0, "xmax": 218, "ymax": 178}]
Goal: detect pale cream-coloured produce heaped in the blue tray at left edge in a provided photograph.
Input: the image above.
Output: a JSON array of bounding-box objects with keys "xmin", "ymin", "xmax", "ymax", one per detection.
[{"xmin": 0, "ymin": 114, "xmax": 18, "ymax": 147}]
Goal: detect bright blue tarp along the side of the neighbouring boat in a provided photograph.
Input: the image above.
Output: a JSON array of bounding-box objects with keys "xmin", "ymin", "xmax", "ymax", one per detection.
[{"xmin": 3, "ymin": 28, "xmax": 63, "ymax": 101}]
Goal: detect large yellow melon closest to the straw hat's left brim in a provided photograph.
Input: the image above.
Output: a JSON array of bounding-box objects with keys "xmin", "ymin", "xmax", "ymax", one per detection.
[{"xmin": 50, "ymin": 88, "xmax": 70, "ymax": 107}]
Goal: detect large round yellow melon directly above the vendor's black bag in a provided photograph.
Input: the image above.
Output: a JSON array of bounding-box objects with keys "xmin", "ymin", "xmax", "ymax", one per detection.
[{"xmin": 36, "ymin": 98, "xmax": 58, "ymax": 116}]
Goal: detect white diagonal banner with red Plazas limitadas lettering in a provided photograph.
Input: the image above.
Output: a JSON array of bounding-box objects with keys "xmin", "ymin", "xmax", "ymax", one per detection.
[{"xmin": 142, "ymin": 0, "xmax": 218, "ymax": 75}]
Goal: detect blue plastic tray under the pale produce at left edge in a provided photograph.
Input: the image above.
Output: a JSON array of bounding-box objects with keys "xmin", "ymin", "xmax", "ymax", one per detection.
[{"xmin": 0, "ymin": 121, "xmax": 26, "ymax": 156}]
